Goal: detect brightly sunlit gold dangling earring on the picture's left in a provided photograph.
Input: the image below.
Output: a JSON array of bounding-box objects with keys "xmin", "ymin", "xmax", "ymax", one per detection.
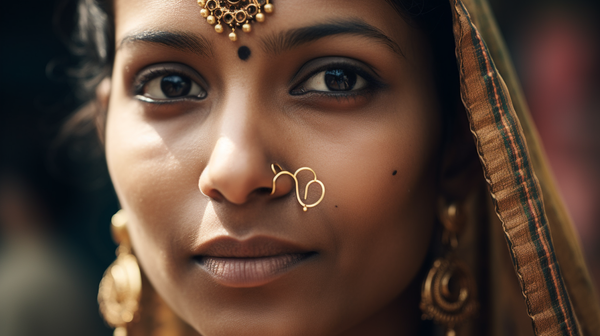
[{"xmin": 98, "ymin": 210, "xmax": 142, "ymax": 336}]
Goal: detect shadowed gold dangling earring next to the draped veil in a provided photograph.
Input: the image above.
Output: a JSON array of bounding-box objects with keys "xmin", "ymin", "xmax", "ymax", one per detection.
[{"xmin": 420, "ymin": 202, "xmax": 479, "ymax": 336}]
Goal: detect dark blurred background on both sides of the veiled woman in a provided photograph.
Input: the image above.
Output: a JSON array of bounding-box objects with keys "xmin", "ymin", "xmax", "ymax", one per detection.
[{"xmin": 0, "ymin": 0, "xmax": 600, "ymax": 336}]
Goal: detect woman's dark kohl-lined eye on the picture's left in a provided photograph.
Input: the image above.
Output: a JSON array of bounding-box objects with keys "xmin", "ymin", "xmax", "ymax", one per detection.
[{"xmin": 140, "ymin": 74, "xmax": 206, "ymax": 100}]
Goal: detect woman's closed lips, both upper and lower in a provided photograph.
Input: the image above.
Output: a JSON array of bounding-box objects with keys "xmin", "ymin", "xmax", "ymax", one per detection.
[{"xmin": 194, "ymin": 237, "xmax": 317, "ymax": 287}]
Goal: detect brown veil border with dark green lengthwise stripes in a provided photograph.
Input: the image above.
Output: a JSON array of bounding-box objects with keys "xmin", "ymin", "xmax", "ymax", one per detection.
[{"xmin": 451, "ymin": 0, "xmax": 581, "ymax": 336}]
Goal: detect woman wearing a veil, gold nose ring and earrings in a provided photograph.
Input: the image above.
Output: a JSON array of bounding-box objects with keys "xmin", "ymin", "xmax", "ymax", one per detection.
[{"xmin": 71, "ymin": 0, "xmax": 600, "ymax": 336}]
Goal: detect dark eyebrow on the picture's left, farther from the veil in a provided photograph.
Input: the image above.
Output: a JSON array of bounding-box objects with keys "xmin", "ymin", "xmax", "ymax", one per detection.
[{"xmin": 117, "ymin": 30, "xmax": 213, "ymax": 56}]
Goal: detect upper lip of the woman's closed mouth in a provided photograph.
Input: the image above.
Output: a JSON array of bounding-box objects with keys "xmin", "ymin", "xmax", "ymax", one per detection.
[{"xmin": 196, "ymin": 236, "xmax": 313, "ymax": 258}]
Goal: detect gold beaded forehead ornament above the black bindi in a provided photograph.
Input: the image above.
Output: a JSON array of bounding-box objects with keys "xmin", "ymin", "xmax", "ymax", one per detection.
[{"xmin": 198, "ymin": 0, "xmax": 274, "ymax": 42}]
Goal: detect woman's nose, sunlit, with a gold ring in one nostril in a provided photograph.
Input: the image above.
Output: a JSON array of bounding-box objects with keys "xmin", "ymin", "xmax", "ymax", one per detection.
[{"xmin": 198, "ymin": 98, "xmax": 292, "ymax": 205}]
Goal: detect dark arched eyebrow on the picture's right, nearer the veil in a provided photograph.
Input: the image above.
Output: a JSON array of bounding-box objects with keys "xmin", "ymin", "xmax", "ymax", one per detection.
[{"xmin": 262, "ymin": 18, "xmax": 404, "ymax": 57}]
